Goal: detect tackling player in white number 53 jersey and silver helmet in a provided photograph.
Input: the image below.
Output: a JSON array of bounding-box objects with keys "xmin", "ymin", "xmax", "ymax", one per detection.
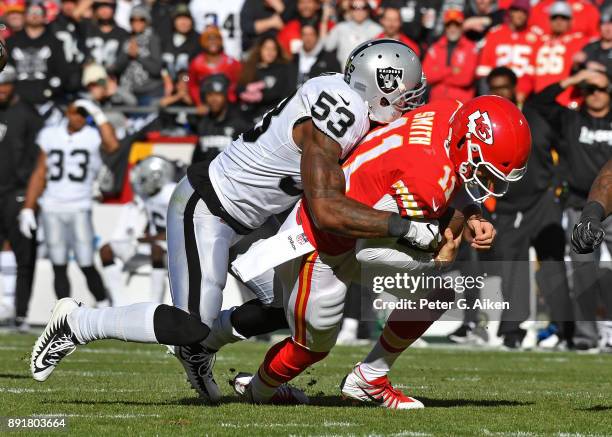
[{"xmin": 31, "ymin": 39, "xmax": 432, "ymax": 402}]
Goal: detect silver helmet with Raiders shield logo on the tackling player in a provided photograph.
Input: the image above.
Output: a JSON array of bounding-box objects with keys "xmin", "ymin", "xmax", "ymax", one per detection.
[{"xmin": 344, "ymin": 39, "xmax": 427, "ymax": 123}]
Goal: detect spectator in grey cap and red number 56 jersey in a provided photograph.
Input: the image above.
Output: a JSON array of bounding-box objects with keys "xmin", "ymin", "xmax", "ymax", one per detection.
[{"xmin": 521, "ymin": 1, "xmax": 587, "ymax": 107}]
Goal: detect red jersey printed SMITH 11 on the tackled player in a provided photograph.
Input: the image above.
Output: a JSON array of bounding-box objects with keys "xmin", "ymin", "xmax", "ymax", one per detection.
[{"xmin": 298, "ymin": 99, "xmax": 461, "ymax": 255}]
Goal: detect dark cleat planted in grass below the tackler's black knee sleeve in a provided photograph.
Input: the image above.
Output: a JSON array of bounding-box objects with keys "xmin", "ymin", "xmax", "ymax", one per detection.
[{"xmin": 174, "ymin": 344, "xmax": 221, "ymax": 404}]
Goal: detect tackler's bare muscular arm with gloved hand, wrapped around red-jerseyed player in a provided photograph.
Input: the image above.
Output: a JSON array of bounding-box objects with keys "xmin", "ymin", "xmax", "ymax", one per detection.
[{"xmin": 300, "ymin": 121, "xmax": 437, "ymax": 246}]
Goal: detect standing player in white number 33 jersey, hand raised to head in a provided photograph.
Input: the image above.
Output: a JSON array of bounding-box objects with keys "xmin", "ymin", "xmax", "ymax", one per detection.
[{"xmin": 19, "ymin": 100, "xmax": 119, "ymax": 306}]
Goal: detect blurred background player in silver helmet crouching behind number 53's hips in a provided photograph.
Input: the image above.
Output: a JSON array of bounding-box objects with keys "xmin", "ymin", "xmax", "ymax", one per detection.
[{"xmin": 100, "ymin": 155, "xmax": 176, "ymax": 303}]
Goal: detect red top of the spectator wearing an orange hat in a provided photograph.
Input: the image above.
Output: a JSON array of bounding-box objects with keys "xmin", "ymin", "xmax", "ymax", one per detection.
[{"xmin": 189, "ymin": 53, "xmax": 242, "ymax": 106}]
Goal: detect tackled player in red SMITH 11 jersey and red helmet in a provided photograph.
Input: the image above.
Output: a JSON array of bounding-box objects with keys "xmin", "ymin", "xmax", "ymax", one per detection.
[{"xmin": 234, "ymin": 96, "xmax": 531, "ymax": 409}]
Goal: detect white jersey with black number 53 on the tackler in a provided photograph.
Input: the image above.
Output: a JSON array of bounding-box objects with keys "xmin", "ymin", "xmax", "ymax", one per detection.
[{"xmin": 209, "ymin": 74, "xmax": 370, "ymax": 229}]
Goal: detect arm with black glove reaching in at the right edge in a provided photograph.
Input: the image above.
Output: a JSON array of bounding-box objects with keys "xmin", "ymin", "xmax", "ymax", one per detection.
[{"xmin": 572, "ymin": 159, "xmax": 612, "ymax": 254}]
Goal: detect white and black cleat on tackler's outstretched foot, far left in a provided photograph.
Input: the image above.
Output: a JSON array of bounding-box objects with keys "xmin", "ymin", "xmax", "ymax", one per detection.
[{"xmin": 30, "ymin": 297, "xmax": 81, "ymax": 382}]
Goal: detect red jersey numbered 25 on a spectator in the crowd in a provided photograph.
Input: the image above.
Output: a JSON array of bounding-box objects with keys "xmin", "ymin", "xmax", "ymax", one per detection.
[{"xmin": 476, "ymin": 24, "xmax": 539, "ymax": 91}]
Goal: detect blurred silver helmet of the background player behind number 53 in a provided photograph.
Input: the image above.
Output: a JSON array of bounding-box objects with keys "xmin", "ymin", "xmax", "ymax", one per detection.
[{"xmin": 130, "ymin": 155, "xmax": 176, "ymax": 197}]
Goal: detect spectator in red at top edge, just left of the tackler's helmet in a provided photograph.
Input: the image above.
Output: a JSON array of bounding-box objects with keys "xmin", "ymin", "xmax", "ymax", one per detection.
[{"xmin": 278, "ymin": 0, "xmax": 330, "ymax": 55}]
